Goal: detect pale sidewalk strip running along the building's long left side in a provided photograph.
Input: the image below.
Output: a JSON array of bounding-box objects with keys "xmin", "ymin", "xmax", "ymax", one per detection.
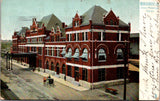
[{"xmin": 12, "ymin": 61, "xmax": 89, "ymax": 91}]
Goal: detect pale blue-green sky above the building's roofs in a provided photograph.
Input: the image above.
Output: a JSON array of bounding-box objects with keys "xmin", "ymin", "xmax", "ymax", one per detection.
[{"xmin": 1, "ymin": 0, "xmax": 139, "ymax": 40}]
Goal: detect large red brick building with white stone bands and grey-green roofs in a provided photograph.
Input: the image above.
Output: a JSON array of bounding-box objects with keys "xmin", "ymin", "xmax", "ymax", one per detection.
[{"xmin": 12, "ymin": 6, "xmax": 130, "ymax": 87}]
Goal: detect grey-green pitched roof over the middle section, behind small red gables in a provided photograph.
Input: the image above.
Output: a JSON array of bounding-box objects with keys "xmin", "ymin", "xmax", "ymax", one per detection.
[{"xmin": 39, "ymin": 14, "xmax": 65, "ymax": 35}]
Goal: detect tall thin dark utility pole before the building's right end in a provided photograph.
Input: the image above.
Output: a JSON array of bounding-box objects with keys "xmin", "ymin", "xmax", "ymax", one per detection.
[{"xmin": 123, "ymin": 40, "xmax": 128, "ymax": 100}]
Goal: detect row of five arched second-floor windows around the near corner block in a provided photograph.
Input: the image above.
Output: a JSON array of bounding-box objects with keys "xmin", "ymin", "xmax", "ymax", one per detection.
[{"xmin": 65, "ymin": 44, "xmax": 124, "ymax": 62}]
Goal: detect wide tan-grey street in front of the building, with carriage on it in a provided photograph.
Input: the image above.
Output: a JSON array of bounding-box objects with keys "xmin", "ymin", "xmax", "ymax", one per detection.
[{"xmin": 1, "ymin": 60, "xmax": 118, "ymax": 100}]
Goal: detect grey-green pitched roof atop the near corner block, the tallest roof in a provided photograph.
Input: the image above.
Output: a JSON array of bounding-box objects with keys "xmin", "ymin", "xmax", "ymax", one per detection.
[{"xmin": 68, "ymin": 5, "xmax": 128, "ymax": 28}]
